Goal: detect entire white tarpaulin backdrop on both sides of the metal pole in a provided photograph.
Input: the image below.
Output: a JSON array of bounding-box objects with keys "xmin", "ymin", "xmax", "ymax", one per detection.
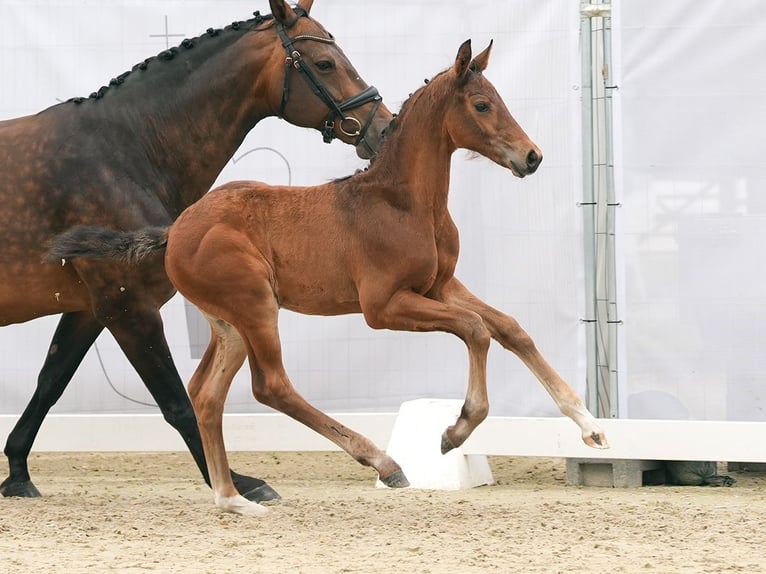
[{"xmin": 0, "ymin": 0, "xmax": 766, "ymax": 421}]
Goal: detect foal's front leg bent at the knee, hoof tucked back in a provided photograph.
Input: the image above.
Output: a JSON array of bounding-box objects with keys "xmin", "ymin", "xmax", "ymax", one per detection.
[{"xmin": 361, "ymin": 288, "xmax": 490, "ymax": 453}]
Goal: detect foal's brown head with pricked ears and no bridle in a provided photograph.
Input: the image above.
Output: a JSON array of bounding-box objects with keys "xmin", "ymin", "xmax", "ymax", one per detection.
[{"xmin": 431, "ymin": 40, "xmax": 543, "ymax": 177}]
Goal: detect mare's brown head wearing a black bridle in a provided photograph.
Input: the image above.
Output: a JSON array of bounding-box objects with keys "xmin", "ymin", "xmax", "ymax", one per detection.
[{"xmin": 266, "ymin": 0, "xmax": 392, "ymax": 158}]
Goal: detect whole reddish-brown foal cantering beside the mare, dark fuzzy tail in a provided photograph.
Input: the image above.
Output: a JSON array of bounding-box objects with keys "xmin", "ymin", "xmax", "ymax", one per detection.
[{"xmin": 50, "ymin": 42, "xmax": 607, "ymax": 514}]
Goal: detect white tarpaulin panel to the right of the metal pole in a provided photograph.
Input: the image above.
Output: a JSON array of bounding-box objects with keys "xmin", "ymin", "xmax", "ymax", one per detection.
[{"xmin": 614, "ymin": 0, "xmax": 766, "ymax": 421}]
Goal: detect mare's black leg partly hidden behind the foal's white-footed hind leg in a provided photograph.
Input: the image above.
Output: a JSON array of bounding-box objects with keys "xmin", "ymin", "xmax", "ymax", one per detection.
[{"xmin": 92, "ymin": 300, "xmax": 280, "ymax": 502}]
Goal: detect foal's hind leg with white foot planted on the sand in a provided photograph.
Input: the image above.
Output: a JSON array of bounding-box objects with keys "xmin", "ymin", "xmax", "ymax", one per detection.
[{"xmin": 189, "ymin": 314, "xmax": 268, "ymax": 516}]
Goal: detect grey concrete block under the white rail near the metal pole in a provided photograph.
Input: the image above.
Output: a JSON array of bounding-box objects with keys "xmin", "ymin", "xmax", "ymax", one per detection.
[{"xmin": 567, "ymin": 458, "xmax": 665, "ymax": 488}]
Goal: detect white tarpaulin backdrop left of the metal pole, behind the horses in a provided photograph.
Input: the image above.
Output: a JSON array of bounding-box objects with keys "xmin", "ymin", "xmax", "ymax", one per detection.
[{"xmin": 0, "ymin": 0, "xmax": 585, "ymax": 415}]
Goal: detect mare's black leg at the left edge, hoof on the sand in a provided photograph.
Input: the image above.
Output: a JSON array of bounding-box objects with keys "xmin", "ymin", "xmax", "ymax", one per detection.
[{"xmin": 0, "ymin": 312, "xmax": 104, "ymax": 497}]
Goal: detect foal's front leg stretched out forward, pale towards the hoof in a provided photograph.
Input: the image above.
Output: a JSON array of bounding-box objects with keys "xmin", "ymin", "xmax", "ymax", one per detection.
[{"xmin": 441, "ymin": 277, "xmax": 609, "ymax": 448}]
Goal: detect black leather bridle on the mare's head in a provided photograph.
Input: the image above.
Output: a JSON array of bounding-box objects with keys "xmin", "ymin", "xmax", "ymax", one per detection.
[{"xmin": 275, "ymin": 7, "xmax": 382, "ymax": 155}]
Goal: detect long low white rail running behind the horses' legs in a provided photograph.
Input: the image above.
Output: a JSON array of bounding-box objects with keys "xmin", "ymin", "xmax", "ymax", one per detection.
[{"xmin": 0, "ymin": 413, "xmax": 766, "ymax": 462}]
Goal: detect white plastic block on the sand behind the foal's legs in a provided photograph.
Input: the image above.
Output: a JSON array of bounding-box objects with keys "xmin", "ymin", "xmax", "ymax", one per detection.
[{"xmin": 377, "ymin": 399, "xmax": 495, "ymax": 490}]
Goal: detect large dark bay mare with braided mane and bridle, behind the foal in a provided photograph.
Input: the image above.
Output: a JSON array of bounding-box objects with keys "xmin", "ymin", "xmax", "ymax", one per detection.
[{"xmin": 0, "ymin": 0, "xmax": 392, "ymax": 500}]
